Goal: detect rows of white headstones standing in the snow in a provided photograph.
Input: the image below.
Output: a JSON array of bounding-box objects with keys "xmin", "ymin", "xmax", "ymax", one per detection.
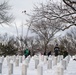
[{"xmin": 0, "ymin": 55, "xmax": 70, "ymax": 75}]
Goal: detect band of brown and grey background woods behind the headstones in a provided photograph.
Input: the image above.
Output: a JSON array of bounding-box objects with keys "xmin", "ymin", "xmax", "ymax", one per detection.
[{"xmin": 0, "ymin": 28, "xmax": 76, "ymax": 56}]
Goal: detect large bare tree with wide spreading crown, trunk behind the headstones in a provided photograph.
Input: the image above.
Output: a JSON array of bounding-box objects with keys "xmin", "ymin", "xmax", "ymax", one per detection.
[{"xmin": 23, "ymin": 0, "xmax": 76, "ymax": 54}]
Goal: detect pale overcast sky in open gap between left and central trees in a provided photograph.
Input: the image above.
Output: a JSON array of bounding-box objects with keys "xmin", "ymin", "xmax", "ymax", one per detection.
[{"xmin": 0, "ymin": 0, "xmax": 47, "ymax": 35}]
